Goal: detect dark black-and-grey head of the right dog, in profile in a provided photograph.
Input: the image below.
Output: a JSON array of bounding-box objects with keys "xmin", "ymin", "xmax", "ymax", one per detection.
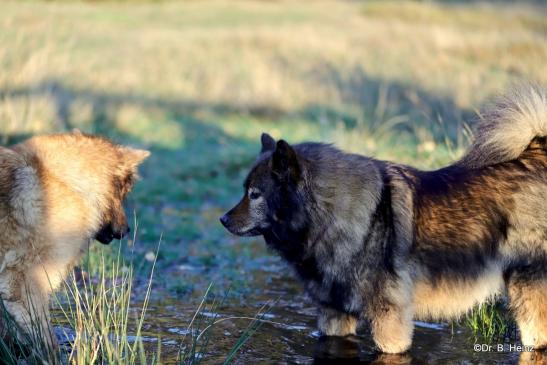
[{"xmin": 220, "ymin": 134, "xmax": 303, "ymax": 236}]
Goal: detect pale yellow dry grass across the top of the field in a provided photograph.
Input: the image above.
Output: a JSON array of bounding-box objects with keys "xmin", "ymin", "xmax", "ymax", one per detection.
[{"xmin": 0, "ymin": 1, "xmax": 547, "ymax": 139}]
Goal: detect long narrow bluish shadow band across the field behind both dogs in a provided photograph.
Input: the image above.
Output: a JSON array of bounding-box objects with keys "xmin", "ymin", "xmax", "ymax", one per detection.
[{"xmin": 0, "ymin": 64, "xmax": 474, "ymax": 142}]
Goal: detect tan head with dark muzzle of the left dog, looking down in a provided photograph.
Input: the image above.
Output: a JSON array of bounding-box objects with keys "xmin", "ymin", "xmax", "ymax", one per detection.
[{"xmin": 37, "ymin": 130, "xmax": 150, "ymax": 244}]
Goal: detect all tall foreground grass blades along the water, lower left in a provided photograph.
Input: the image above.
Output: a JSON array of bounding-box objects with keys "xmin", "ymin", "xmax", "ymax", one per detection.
[{"xmin": 0, "ymin": 239, "xmax": 267, "ymax": 365}]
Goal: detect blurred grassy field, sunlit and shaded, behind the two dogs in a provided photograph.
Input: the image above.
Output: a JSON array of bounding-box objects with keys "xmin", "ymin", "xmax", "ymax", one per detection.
[{"xmin": 0, "ymin": 1, "xmax": 547, "ymax": 362}]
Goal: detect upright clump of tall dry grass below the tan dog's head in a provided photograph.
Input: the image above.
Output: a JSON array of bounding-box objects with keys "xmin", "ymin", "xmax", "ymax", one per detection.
[{"xmin": 61, "ymin": 240, "xmax": 160, "ymax": 364}]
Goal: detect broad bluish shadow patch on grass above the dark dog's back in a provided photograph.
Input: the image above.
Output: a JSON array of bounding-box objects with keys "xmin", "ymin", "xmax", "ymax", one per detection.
[{"xmin": 300, "ymin": 64, "xmax": 475, "ymax": 139}]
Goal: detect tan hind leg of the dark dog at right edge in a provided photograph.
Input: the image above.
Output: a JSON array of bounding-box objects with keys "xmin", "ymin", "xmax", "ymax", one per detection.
[{"xmin": 506, "ymin": 260, "xmax": 547, "ymax": 349}]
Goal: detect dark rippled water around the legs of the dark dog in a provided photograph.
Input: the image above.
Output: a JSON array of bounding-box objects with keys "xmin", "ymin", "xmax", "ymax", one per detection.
[{"xmin": 54, "ymin": 253, "xmax": 547, "ymax": 364}]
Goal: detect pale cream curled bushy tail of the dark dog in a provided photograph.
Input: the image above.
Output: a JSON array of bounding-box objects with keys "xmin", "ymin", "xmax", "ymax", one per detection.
[{"xmin": 459, "ymin": 85, "xmax": 547, "ymax": 168}]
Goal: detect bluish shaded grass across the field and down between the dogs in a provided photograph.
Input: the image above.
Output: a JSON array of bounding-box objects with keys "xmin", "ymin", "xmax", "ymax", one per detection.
[{"xmin": 0, "ymin": 71, "xmax": 480, "ymax": 286}]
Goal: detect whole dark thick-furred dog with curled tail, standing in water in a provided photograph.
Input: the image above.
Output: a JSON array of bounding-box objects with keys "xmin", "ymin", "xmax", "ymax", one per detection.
[{"xmin": 221, "ymin": 87, "xmax": 547, "ymax": 353}]
